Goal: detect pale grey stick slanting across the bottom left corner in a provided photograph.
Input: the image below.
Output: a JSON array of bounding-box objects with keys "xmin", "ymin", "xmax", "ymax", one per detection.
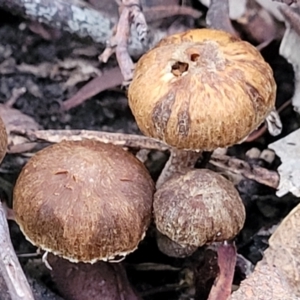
[{"xmin": 0, "ymin": 202, "xmax": 34, "ymax": 300}]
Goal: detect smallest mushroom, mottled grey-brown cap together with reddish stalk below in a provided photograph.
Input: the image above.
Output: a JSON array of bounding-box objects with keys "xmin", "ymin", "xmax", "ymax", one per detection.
[{"xmin": 153, "ymin": 169, "xmax": 245, "ymax": 300}]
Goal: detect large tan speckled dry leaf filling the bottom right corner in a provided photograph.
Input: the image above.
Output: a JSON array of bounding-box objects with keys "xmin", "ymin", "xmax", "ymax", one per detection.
[{"xmin": 230, "ymin": 204, "xmax": 300, "ymax": 300}]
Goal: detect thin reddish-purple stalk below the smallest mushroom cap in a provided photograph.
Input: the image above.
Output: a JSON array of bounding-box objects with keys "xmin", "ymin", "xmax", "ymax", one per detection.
[{"xmin": 208, "ymin": 241, "xmax": 236, "ymax": 300}]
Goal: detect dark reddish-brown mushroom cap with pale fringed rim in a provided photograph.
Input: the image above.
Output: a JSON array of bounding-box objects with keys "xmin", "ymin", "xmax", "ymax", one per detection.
[{"xmin": 13, "ymin": 140, "xmax": 154, "ymax": 263}]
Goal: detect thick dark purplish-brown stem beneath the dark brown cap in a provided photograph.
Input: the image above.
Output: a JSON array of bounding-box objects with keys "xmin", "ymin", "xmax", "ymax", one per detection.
[{"xmin": 49, "ymin": 254, "xmax": 141, "ymax": 300}]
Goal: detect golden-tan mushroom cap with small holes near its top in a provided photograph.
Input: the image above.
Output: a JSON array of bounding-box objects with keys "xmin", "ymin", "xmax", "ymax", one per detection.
[{"xmin": 128, "ymin": 29, "xmax": 276, "ymax": 151}]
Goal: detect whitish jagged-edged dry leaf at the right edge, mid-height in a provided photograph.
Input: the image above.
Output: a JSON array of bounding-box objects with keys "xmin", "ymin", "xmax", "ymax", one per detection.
[{"xmin": 268, "ymin": 129, "xmax": 300, "ymax": 197}]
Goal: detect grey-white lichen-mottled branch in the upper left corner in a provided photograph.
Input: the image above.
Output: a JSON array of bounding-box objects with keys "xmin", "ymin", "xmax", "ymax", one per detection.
[{"xmin": 0, "ymin": 0, "xmax": 116, "ymax": 44}]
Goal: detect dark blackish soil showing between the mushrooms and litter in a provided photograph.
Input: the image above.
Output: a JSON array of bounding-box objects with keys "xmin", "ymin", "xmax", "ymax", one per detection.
[{"xmin": 0, "ymin": 4, "xmax": 300, "ymax": 300}]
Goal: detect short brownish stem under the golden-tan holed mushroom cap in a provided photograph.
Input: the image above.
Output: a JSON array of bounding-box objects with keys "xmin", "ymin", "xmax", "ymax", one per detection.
[{"xmin": 156, "ymin": 148, "xmax": 202, "ymax": 188}]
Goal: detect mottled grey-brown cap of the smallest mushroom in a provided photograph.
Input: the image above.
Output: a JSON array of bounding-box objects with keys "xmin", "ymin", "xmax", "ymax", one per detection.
[{"xmin": 153, "ymin": 169, "xmax": 245, "ymax": 247}]
